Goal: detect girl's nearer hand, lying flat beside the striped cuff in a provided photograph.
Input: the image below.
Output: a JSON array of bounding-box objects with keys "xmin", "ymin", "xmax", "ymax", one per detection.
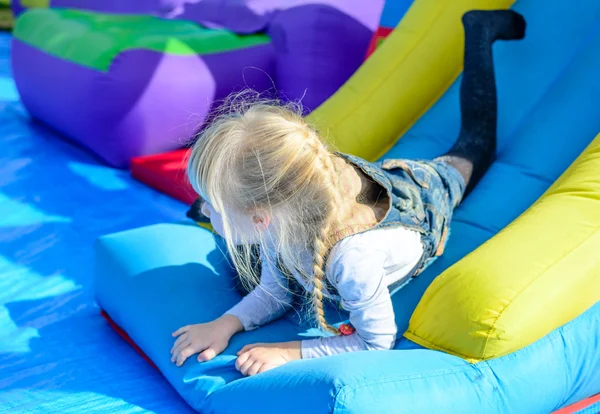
[{"xmin": 235, "ymin": 341, "xmax": 302, "ymax": 376}]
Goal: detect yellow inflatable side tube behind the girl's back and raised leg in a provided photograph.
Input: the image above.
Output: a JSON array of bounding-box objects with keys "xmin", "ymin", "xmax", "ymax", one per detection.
[{"xmin": 308, "ymin": 0, "xmax": 514, "ymax": 161}]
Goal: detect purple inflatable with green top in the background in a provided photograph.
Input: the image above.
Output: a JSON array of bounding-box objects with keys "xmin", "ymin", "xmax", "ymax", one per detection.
[{"xmin": 12, "ymin": 0, "xmax": 383, "ymax": 168}]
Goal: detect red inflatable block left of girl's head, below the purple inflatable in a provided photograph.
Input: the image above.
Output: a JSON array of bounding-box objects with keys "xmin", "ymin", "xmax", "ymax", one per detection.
[{"xmin": 131, "ymin": 148, "xmax": 197, "ymax": 204}]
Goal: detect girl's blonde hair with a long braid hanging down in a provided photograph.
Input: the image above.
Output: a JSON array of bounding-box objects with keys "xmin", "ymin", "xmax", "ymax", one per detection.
[{"xmin": 188, "ymin": 94, "xmax": 343, "ymax": 334}]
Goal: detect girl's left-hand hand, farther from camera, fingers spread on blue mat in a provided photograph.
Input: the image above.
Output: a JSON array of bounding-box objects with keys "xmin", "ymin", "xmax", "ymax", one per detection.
[{"xmin": 171, "ymin": 315, "xmax": 243, "ymax": 367}]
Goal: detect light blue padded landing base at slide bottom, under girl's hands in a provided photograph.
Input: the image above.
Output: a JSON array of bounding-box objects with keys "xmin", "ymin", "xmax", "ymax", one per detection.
[{"xmin": 95, "ymin": 224, "xmax": 600, "ymax": 413}]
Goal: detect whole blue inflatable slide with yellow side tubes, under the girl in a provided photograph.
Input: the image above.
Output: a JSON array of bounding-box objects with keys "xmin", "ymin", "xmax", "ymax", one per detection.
[{"xmin": 94, "ymin": 0, "xmax": 600, "ymax": 414}]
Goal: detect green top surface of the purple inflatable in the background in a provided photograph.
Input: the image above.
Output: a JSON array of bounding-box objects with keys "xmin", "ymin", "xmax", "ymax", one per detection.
[{"xmin": 13, "ymin": 9, "xmax": 270, "ymax": 72}]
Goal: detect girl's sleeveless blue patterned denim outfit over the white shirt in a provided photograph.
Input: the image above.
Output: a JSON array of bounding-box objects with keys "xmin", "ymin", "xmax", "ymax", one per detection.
[{"xmin": 337, "ymin": 153, "xmax": 465, "ymax": 284}]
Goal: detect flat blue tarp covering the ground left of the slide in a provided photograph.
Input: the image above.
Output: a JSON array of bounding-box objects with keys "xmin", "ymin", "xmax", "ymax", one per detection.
[{"xmin": 0, "ymin": 34, "xmax": 192, "ymax": 414}]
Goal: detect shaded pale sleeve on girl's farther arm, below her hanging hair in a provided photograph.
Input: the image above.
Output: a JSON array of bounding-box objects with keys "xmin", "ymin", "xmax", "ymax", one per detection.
[{"xmin": 225, "ymin": 250, "xmax": 292, "ymax": 331}]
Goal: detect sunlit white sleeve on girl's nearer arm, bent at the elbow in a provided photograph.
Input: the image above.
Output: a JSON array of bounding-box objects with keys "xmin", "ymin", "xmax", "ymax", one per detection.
[{"xmin": 302, "ymin": 246, "xmax": 398, "ymax": 359}]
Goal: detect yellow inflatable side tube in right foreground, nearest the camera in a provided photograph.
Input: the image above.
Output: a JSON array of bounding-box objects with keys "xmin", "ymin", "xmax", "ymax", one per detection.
[{"xmin": 405, "ymin": 135, "xmax": 600, "ymax": 362}]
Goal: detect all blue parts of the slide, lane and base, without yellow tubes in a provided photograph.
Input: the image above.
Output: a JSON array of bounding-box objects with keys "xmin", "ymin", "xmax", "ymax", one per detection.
[{"xmin": 96, "ymin": 0, "xmax": 600, "ymax": 413}]
